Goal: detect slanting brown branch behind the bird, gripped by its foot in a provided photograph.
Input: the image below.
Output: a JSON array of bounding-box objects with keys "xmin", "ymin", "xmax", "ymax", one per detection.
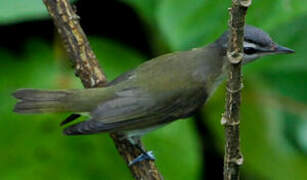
[{"xmin": 43, "ymin": 0, "xmax": 162, "ymax": 180}]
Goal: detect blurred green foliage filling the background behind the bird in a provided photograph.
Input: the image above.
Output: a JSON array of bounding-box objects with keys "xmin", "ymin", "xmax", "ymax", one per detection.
[{"xmin": 0, "ymin": 0, "xmax": 307, "ymax": 180}]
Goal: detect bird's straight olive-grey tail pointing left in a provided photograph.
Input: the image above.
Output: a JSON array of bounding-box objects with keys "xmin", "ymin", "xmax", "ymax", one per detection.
[{"xmin": 13, "ymin": 89, "xmax": 74, "ymax": 113}]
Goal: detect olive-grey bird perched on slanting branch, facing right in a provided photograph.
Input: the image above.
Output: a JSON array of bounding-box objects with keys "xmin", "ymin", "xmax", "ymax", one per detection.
[{"xmin": 13, "ymin": 25, "xmax": 294, "ymax": 165}]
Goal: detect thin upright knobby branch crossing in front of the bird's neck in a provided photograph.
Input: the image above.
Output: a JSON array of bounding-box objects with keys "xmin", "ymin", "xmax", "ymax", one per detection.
[{"xmin": 222, "ymin": 0, "xmax": 251, "ymax": 180}]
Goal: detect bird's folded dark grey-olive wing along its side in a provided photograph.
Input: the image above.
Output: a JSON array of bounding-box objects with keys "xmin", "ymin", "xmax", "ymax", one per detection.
[{"xmin": 64, "ymin": 86, "xmax": 206, "ymax": 135}]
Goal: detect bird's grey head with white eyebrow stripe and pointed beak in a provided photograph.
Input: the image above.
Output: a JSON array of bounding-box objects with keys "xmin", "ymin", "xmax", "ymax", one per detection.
[{"xmin": 217, "ymin": 25, "xmax": 294, "ymax": 64}]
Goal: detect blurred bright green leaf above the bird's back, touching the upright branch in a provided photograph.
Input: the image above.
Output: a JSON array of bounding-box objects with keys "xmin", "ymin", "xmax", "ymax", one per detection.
[{"xmin": 157, "ymin": 0, "xmax": 228, "ymax": 50}]
